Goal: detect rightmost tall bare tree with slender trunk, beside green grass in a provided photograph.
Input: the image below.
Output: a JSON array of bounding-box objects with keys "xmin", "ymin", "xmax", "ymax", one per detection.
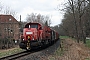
[{"xmin": 76, "ymin": 0, "xmax": 87, "ymax": 43}]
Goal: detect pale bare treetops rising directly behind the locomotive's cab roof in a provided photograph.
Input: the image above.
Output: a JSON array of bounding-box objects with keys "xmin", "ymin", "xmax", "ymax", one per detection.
[{"xmin": 26, "ymin": 13, "xmax": 51, "ymax": 25}]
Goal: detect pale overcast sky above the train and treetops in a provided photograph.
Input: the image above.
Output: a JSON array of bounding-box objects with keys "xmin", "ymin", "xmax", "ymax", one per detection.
[{"xmin": 1, "ymin": 0, "xmax": 65, "ymax": 26}]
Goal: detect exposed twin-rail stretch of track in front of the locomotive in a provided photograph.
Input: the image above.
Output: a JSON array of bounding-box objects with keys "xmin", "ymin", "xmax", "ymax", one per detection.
[{"xmin": 0, "ymin": 51, "xmax": 33, "ymax": 60}]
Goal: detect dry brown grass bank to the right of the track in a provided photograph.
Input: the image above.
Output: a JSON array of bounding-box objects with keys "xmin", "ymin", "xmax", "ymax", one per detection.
[{"xmin": 49, "ymin": 39, "xmax": 90, "ymax": 60}]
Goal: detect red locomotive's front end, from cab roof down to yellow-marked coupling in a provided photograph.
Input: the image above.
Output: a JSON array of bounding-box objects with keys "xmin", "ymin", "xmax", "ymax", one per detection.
[{"xmin": 22, "ymin": 23, "xmax": 42, "ymax": 49}]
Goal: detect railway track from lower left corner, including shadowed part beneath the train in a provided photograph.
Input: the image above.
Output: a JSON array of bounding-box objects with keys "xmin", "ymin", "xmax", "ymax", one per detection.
[{"xmin": 0, "ymin": 39, "xmax": 59, "ymax": 60}]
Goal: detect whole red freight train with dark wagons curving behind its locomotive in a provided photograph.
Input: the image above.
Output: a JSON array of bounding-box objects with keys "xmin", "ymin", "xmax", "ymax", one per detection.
[{"xmin": 19, "ymin": 23, "xmax": 59, "ymax": 50}]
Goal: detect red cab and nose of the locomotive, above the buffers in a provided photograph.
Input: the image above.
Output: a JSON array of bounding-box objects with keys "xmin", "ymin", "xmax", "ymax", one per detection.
[{"xmin": 23, "ymin": 23, "xmax": 40, "ymax": 41}]
